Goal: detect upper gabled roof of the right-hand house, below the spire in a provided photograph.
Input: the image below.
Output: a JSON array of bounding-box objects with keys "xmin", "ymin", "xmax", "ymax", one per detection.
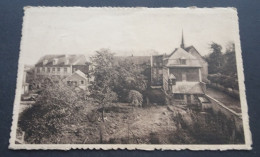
[{"xmin": 165, "ymin": 48, "xmax": 202, "ymax": 67}]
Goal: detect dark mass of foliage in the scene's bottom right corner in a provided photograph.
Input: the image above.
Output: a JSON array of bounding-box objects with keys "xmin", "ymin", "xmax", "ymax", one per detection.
[{"xmin": 172, "ymin": 110, "xmax": 244, "ymax": 144}]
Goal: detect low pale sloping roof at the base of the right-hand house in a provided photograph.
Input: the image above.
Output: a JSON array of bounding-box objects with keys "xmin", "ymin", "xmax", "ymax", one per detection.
[{"xmin": 172, "ymin": 82, "xmax": 204, "ymax": 94}]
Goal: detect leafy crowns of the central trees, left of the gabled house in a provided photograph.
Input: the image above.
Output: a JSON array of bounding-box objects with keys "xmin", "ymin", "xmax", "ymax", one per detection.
[{"xmin": 91, "ymin": 49, "xmax": 147, "ymax": 102}]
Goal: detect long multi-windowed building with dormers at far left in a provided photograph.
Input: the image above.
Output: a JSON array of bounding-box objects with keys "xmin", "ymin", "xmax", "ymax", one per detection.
[{"xmin": 34, "ymin": 55, "xmax": 90, "ymax": 79}]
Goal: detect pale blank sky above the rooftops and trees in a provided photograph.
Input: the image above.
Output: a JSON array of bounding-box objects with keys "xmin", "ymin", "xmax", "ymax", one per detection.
[{"xmin": 20, "ymin": 7, "xmax": 239, "ymax": 64}]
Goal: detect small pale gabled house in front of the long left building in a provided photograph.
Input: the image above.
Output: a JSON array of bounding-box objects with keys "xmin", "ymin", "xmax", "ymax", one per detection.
[{"xmin": 62, "ymin": 70, "xmax": 90, "ymax": 90}]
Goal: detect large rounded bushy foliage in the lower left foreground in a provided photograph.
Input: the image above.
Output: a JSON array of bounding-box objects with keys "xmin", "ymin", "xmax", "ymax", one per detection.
[{"xmin": 18, "ymin": 83, "xmax": 87, "ymax": 143}]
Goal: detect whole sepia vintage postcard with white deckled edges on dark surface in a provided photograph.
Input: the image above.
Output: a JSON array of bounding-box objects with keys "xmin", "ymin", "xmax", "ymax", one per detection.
[{"xmin": 9, "ymin": 7, "xmax": 252, "ymax": 150}]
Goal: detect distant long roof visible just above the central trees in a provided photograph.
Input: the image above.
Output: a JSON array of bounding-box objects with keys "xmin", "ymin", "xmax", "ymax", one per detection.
[{"xmin": 114, "ymin": 56, "xmax": 151, "ymax": 65}]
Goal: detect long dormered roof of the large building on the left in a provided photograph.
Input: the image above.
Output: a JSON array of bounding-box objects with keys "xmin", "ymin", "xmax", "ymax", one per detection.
[{"xmin": 35, "ymin": 54, "xmax": 87, "ymax": 66}]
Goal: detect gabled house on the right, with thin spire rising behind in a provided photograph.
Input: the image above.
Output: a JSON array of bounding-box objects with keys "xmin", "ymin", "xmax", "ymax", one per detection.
[{"xmin": 151, "ymin": 32, "xmax": 208, "ymax": 104}]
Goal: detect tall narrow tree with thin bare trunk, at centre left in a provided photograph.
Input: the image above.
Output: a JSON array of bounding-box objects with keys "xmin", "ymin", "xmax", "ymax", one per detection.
[{"xmin": 90, "ymin": 49, "xmax": 118, "ymax": 122}]
